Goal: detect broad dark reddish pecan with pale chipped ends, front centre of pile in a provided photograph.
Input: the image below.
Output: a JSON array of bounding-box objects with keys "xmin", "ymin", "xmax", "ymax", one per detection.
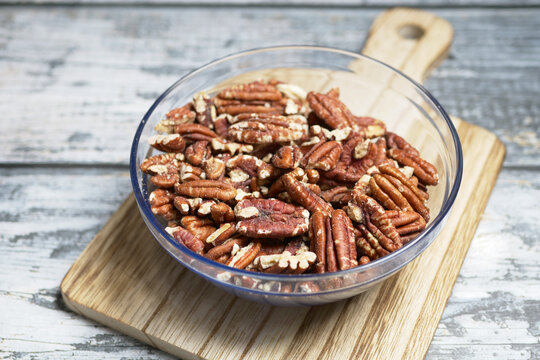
[{"xmin": 234, "ymin": 199, "xmax": 309, "ymax": 239}]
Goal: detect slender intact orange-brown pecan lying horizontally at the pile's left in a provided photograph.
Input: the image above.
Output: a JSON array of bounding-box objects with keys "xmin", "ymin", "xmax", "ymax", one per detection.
[{"xmin": 174, "ymin": 180, "xmax": 236, "ymax": 201}]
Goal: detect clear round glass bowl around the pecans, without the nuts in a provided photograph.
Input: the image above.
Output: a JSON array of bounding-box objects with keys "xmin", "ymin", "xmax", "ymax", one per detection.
[{"xmin": 130, "ymin": 46, "xmax": 463, "ymax": 306}]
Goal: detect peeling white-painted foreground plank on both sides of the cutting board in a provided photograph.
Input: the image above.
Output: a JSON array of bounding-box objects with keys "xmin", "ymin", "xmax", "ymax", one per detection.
[{"xmin": 0, "ymin": 168, "xmax": 540, "ymax": 359}]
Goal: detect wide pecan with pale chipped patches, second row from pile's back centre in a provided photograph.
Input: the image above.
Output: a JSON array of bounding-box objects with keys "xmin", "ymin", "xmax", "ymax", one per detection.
[{"xmin": 229, "ymin": 114, "xmax": 307, "ymax": 144}]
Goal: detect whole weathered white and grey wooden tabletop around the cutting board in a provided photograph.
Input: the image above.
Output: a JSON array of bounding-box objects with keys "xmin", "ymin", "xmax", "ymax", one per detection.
[{"xmin": 0, "ymin": 0, "xmax": 540, "ymax": 359}]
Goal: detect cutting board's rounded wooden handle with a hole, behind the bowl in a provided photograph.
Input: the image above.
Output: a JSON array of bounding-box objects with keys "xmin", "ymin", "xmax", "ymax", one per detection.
[{"xmin": 362, "ymin": 8, "xmax": 454, "ymax": 82}]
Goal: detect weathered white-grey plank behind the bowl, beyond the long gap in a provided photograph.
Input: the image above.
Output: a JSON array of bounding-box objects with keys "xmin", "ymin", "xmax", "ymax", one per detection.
[{"xmin": 0, "ymin": 7, "xmax": 540, "ymax": 166}]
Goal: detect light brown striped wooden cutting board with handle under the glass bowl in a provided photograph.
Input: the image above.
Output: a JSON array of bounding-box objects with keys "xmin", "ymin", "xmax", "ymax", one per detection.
[{"xmin": 61, "ymin": 9, "xmax": 505, "ymax": 359}]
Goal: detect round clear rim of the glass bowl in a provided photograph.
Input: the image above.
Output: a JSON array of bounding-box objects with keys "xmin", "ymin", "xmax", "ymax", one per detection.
[{"xmin": 130, "ymin": 45, "xmax": 463, "ymax": 288}]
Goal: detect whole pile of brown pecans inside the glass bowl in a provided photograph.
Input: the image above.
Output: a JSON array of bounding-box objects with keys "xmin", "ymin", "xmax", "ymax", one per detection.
[{"xmin": 141, "ymin": 80, "xmax": 438, "ymax": 274}]
